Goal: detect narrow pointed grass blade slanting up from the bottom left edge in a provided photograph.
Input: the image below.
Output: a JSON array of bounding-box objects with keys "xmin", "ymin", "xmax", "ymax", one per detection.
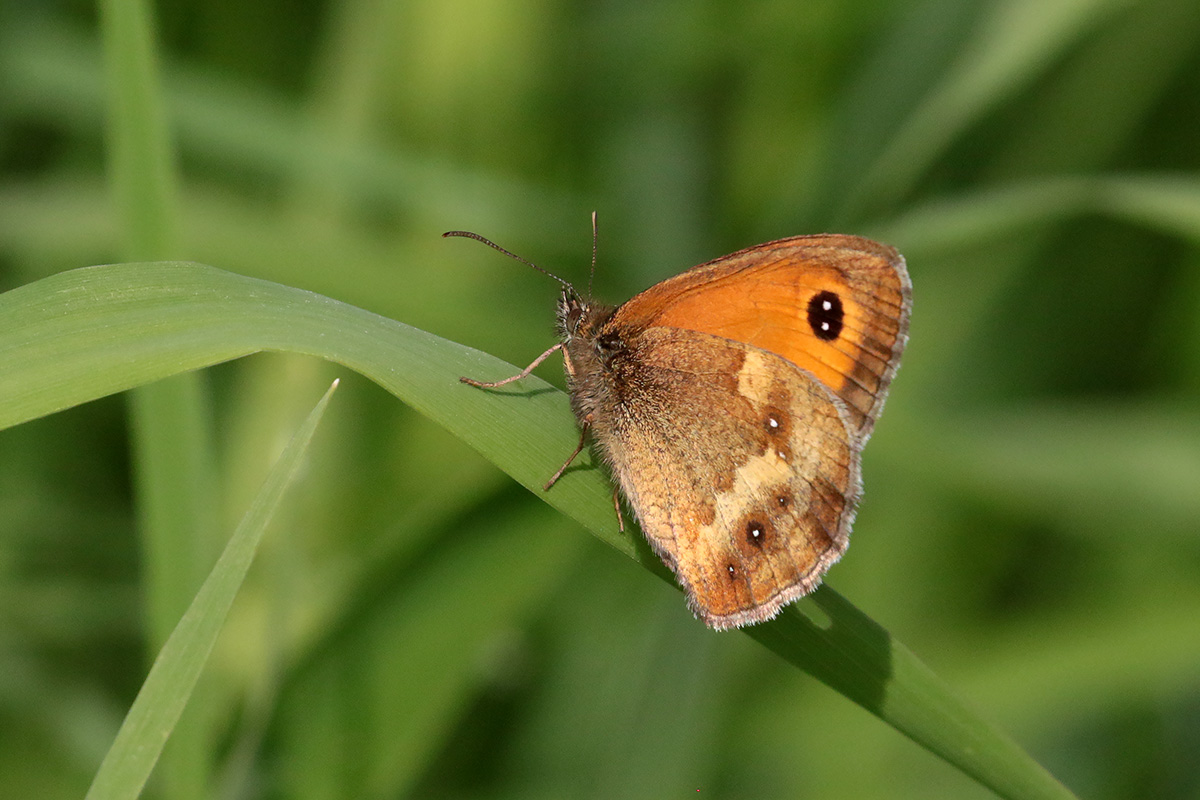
[{"xmin": 86, "ymin": 381, "xmax": 337, "ymax": 800}]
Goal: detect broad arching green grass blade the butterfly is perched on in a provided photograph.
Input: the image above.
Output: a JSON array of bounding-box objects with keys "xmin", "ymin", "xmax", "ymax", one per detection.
[{"xmin": 0, "ymin": 263, "xmax": 1070, "ymax": 798}]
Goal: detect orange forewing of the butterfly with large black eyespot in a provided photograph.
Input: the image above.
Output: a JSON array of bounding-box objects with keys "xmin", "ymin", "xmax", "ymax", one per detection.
[{"xmin": 613, "ymin": 235, "xmax": 912, "ymax": 434}]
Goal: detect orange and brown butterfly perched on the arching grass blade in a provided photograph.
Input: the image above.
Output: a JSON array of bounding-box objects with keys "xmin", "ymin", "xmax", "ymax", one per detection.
[{"xmin": 445, "ymin": 223, "xmax": 912, "ymax": 630}]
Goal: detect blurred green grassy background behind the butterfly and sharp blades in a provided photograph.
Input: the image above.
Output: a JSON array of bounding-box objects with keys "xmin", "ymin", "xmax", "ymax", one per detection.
[{"xmin": 0, "ymin": 0, "xmax": 1200, "ymax": 800}]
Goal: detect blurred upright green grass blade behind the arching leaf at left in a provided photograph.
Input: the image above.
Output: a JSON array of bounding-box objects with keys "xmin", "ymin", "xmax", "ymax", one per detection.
[{"xmin": 100, "ymin": 0, "xmax": 221, "ymax": 800}]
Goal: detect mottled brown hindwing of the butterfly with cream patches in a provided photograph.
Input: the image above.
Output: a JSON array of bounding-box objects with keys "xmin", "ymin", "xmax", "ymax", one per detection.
[{"xmin": 583, "ymin": 327, "xmax": 859, "ymax": 627}]
